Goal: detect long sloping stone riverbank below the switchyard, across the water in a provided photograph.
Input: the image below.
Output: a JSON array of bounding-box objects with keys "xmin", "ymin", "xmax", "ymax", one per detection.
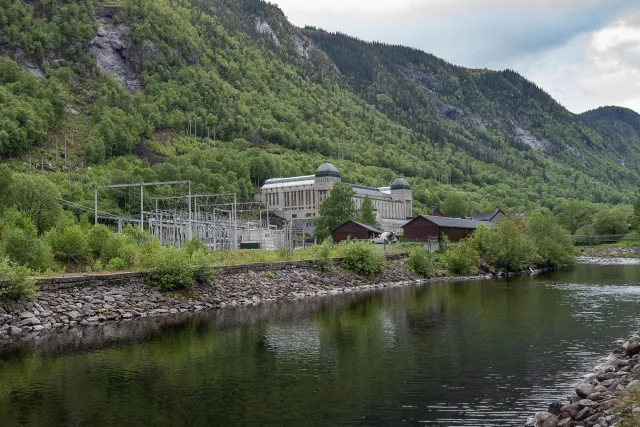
[{"xmin": 0, "ymin": 254, "xmax": 556, "ymax": 346}]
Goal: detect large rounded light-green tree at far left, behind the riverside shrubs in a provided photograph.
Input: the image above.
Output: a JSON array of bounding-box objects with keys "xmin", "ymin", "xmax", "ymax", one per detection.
[{"xmin": 9, "ymin": 174, "xmax": 62, "ymax": 234}]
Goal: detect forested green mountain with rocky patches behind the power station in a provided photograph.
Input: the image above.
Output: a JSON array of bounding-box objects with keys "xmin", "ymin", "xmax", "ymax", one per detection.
[{"xmin": 0, "ymin": 0, "xmax": 640, "ymax": 216}]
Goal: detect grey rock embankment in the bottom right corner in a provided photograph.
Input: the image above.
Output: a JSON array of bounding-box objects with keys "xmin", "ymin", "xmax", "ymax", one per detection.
[{"xmin": 525, "ymin": 335, "xmax": 640, "ymax": 427}]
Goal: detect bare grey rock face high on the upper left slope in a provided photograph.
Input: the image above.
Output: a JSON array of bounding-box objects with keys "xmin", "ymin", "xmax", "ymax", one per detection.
[{"xmin": 90, "ymin": 10, "xmax": 142, "ymax": 91}]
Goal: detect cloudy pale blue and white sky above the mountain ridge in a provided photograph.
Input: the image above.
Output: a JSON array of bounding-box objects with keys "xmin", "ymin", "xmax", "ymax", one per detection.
[{"xmin": 271, "ymin": 0, "xmax": 640, "ymax": 113}]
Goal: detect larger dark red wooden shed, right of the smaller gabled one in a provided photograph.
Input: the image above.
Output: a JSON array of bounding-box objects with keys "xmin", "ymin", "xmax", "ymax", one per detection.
[{"xmin": 402, "ymin": 215, "xmax": 491, "ymax": 242}]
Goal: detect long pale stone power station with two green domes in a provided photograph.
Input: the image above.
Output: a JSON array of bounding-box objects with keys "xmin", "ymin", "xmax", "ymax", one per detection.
[{"xmin": 260, "ymin": 161, "xmax": 413, "ymax": 231}]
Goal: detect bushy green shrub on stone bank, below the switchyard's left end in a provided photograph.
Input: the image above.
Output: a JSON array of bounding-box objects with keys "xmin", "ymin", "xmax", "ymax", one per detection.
[{"xmin": 144, "ymin": 243, "xmax": 194, "ymax": 292}]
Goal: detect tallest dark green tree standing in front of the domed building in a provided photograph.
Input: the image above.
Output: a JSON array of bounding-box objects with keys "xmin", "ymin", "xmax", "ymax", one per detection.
[{"xmin": 315, "ymin": 183, "xmax": 356, "ymax": 240}]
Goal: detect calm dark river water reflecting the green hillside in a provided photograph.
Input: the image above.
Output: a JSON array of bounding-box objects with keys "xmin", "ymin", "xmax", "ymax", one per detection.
[{"xmin": 0, "ymin": 266, "xmax": 640, "ymax": 426}]
